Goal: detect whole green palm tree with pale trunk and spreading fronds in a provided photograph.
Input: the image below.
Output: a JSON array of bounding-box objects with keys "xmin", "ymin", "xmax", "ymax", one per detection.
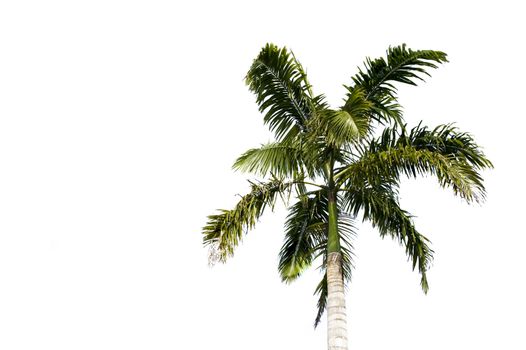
[{"xmin": 203, "ymin": 44, "xmax": 492, "ymax": 350}]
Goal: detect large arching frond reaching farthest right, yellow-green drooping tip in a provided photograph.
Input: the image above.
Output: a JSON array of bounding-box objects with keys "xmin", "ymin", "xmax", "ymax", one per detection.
[{"xmin": 337, "ymin": 126, "xmax": 492, "ymax": 202}]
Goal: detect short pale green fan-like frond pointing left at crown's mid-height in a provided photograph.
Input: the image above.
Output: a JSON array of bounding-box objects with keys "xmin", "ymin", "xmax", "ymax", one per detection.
[{"xmin": 232, "ymin": 142, "xmax": 305, "ymax": 178}]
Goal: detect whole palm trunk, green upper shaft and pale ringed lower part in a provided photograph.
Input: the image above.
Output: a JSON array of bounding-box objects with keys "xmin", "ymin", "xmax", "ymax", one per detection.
[{"xmin": 327, "ymin": 191, "xmax": 347, "ymax": 350}]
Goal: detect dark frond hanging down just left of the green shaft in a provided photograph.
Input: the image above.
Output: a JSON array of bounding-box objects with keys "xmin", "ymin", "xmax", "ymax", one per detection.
[{"xmin": 278, "ymin": 191, "xmax": 328, "ymax": 282}]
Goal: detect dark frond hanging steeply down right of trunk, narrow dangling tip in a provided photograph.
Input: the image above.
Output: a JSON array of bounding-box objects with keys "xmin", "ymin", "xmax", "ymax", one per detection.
[{"xmin": 343, "ymin": 185, "xmax": 433, "ymax": 293}]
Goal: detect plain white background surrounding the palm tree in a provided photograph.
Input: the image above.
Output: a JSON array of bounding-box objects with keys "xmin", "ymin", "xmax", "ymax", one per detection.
[{"xmin": 0, "ymin": 0, "xmax": 526, "ymax": 350}]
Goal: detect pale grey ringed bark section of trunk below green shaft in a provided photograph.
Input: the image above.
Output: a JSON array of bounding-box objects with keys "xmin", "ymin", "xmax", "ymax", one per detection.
[{"xmin": 327, "ymin": 252, "xmax": 347, "ymax": 350}]
